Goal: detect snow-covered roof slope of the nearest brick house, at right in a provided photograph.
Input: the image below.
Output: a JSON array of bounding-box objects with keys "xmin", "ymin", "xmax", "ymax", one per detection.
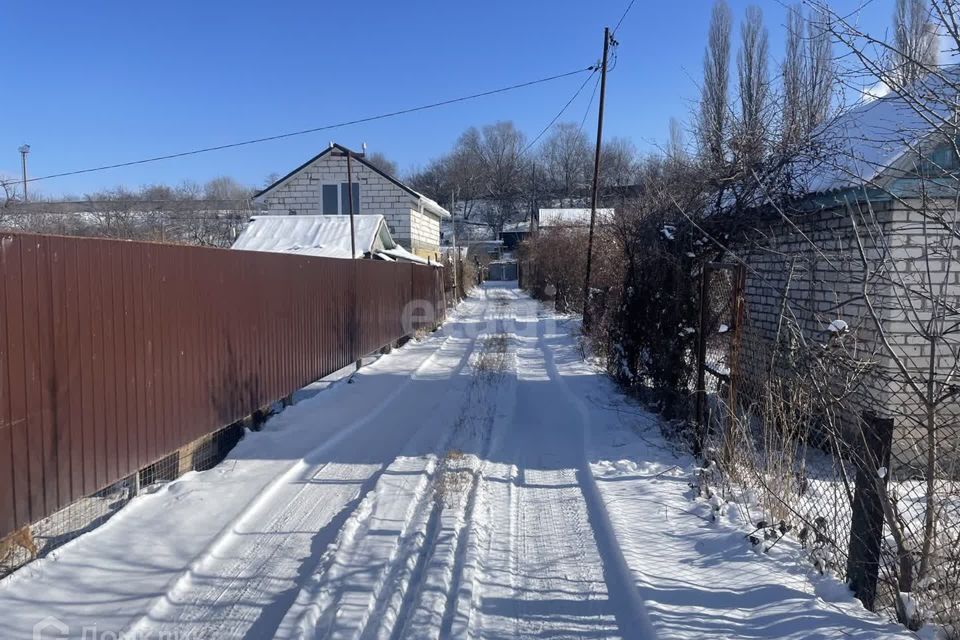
[{"xmin": 799, "ymin": 65, "xmax": 960, "ymax": 193}]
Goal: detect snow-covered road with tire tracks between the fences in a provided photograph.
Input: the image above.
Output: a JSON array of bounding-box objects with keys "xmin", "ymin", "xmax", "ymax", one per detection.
[{"xmin": 0, "ymin": 284, "xmax": 909, "ymax": 640}]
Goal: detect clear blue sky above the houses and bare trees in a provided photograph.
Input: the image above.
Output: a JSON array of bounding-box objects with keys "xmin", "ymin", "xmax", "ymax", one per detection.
[{"xmin": 0, "ymin": 0, "xmax": 893, "ymax": 196}]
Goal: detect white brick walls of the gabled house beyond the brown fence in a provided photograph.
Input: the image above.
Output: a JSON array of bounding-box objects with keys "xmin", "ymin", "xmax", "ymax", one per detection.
[{"xmin": 255, "ymin": 154, "xmax": 440, "ymax": 251}]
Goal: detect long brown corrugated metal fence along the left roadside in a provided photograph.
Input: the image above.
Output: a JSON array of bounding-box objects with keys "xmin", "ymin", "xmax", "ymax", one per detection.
[{"xmin": 0, "ymin": 234, "xmax": 445, "ymax": 538}]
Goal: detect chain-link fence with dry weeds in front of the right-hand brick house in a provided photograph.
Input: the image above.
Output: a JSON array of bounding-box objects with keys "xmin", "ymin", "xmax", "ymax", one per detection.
[{"xmin": 696, "ymin": 265, "xmax": 960, "ymax": 638}]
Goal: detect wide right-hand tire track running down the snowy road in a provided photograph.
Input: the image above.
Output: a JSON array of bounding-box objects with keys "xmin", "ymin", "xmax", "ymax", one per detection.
[{"xmin": 464, "ymin": 298, "xmax": 638, "ymax": 638}]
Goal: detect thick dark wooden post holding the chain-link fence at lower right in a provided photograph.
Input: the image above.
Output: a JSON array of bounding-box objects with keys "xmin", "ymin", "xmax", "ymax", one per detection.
[{"xmin": 847, "ymin": 412, "xmax": 893, "ymax": 611}]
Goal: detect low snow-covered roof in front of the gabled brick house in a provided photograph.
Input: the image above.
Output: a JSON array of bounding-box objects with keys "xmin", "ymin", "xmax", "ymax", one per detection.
[{"xmin": 232, "ymin": 215, "xmax": 427, "ymax": 263}]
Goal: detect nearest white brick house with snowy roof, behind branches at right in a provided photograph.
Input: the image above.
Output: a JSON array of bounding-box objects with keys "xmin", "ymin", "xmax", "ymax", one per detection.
[{"xmin": 716, "ymin": 80, "xmax": 960, "ymax": 473}]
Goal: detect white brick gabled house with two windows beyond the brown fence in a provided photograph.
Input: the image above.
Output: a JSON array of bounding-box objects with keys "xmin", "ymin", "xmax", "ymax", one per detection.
[{"xmin": 253, "ymin": 144, "xmax": 450, "ymax": 259}]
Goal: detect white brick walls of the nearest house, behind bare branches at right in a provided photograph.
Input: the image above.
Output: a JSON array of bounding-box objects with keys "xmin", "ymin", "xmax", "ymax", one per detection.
[{"xmin": 730, "ymin": 202, "xmax": 960, "ymax": 464}]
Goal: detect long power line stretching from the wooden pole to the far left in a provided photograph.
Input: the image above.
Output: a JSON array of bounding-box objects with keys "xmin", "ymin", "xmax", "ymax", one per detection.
[{"xmin": 27, "ymin": 66, "xmax": 596, "ymax": 182}]
